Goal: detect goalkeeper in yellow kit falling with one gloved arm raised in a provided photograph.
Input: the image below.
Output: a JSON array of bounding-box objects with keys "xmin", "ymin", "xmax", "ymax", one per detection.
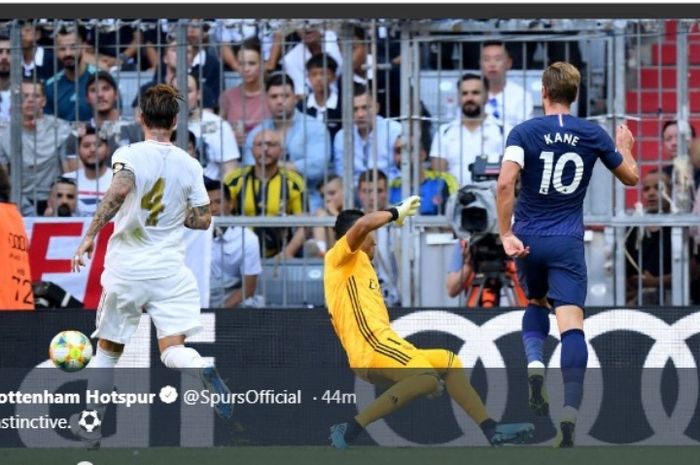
[{"xmin": 323, "ymin": 196, "xmax": 534, "ymax": 449}]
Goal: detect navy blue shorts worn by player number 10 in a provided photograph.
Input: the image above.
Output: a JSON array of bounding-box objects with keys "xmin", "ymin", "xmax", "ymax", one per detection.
[{"xmin": 516, "ymin": 235, "xmax": 588, "ymax": 308}]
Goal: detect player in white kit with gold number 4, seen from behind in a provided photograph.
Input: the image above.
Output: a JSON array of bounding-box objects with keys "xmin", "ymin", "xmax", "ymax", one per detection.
[{"xmin": 72, "ymin": 84, "xmax": 233, "ymax": 448}]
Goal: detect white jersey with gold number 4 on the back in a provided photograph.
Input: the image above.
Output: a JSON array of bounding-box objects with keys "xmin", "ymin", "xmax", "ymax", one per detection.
[{"xmin": 105, "ymin": 140, "xmax": 209, "ymax": 280}]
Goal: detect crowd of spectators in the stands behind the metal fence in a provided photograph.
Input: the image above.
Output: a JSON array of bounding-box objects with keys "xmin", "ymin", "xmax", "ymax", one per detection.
[{"xmin": 0, "ymin": 20, "xmax": 700, "ymax": 306}]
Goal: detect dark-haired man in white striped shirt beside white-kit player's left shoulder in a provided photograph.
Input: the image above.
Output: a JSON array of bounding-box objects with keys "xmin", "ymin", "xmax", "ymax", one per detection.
[{"xmin": 65, "ymin": 126, "xmax": 112, "ymax": 216}]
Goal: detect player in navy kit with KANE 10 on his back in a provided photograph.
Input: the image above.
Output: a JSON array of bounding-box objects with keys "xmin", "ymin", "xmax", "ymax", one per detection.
[{"xmin": 496, "ymin": 62, "xmax": 639, "ymax": 447}]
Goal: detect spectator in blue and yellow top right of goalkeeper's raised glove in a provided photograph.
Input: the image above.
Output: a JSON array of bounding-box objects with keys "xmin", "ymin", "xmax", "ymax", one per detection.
[{"xmin": 389, "ymin": 137, "xmax": 459, "ymax": 215}]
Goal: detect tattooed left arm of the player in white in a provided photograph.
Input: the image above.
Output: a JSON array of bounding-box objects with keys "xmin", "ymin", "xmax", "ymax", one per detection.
[{"xmin": 71, "ymin": 170, "xmax": 136, "ymax": 271}]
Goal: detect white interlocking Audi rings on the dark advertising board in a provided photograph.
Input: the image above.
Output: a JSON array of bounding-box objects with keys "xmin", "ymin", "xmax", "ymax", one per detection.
[{"xmin": 355, "ymin": 309, "xmax": 700, "ymax": 447}]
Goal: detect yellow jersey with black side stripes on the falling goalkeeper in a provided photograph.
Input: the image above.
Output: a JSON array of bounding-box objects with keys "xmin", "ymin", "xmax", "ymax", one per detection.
[{"xmin": 323, "ymin": 236, "xmax": 407, "ymax": 369}]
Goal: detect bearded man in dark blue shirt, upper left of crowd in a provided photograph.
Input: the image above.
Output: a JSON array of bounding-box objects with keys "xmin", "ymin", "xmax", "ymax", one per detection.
[{"xmin": 44, "ymin": 28, "xmax": 97, "ymax": 121}]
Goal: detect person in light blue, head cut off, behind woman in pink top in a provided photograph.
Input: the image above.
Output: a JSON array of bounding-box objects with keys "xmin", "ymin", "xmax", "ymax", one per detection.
[{"xmin": 216, "ymin": 19, "xmax": 284, "ymax": 72}]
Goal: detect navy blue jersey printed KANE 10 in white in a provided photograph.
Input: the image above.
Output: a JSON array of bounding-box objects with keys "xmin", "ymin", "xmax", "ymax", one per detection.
[{"xmin": 503, "ymin": 115, "xmax": 622, "ymax": 238}]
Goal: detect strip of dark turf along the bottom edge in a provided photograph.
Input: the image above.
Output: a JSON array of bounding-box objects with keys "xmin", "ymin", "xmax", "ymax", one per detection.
[{"xmin": 0, "ymin": 446, "xmax": 700, "ymax": 465}]
